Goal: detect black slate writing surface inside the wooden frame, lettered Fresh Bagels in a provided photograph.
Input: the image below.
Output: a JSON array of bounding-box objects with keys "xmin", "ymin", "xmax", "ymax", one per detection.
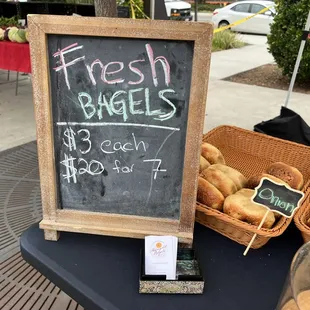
[{"xmin": 48, "ymin": 35, "xmax": 193, "ymax": 219}]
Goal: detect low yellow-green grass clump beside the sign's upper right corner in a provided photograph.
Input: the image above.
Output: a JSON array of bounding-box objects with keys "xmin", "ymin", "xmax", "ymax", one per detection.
[{"xmin": 212, "ymin": 30, "xmax": 246, "ymax": 52}]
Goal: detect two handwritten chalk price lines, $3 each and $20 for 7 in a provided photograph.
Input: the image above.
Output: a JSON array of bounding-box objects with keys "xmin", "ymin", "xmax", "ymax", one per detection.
[{"xmin": 60, "ymin": 127, "xmax": 167, "ymax": 183}]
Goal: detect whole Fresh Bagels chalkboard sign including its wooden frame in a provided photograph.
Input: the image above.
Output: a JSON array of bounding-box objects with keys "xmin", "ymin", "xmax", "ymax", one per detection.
[{"xmin": 29, "ymin": 15, "xmax": 212, "ymax": 243}]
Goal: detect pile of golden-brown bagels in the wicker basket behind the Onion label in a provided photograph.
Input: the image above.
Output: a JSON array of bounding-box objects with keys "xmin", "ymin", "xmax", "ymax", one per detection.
[{"xmin": 197, "ymin": 142, "xmax": 304, "ymax": 229}]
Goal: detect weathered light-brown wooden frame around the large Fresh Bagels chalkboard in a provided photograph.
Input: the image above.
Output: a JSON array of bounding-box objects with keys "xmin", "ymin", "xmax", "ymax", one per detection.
[{"xmin": 28, "ymin": 15, "xmax": 213, "ymax": 244}]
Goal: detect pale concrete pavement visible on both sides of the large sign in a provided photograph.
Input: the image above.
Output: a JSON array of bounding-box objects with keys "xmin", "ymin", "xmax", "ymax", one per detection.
[{"xmin": 0, "ymin": 37, "xmax": 310, "ymax": 150}]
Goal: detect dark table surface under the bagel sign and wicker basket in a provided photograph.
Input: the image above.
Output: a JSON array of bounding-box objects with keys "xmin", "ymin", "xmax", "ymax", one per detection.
[{"xmin": 20, "ymin": 224, "xmax": 302, "ymax": 310}]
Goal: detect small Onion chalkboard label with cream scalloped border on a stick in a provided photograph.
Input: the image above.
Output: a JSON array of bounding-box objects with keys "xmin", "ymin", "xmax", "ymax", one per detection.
[{"xmin": 252, "ymin": 178, "xmax": 304, "ymax": 217}]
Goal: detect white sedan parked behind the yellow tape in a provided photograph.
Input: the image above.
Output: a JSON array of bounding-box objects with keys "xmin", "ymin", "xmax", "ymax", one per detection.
[{"xmin": 212, "ymin": 0, "xmax": 275, "ymax": 34}]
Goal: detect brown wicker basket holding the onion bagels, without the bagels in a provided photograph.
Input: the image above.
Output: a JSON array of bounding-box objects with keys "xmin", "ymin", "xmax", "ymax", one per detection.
[{"xmin": 196, "ymin": 126, "xmax": 310, "ymax": 249}]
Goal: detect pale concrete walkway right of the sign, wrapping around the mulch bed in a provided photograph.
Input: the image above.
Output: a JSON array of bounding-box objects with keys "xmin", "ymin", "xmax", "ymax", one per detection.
[{"xmin": 204, "ymin": 40, "xmax": 310, "ymax": 132}]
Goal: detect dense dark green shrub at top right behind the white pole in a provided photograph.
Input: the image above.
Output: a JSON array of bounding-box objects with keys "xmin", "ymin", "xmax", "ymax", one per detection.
[{"xmin": 268, "ymin": 0, "xmax": 310, "ymax": 82}]
